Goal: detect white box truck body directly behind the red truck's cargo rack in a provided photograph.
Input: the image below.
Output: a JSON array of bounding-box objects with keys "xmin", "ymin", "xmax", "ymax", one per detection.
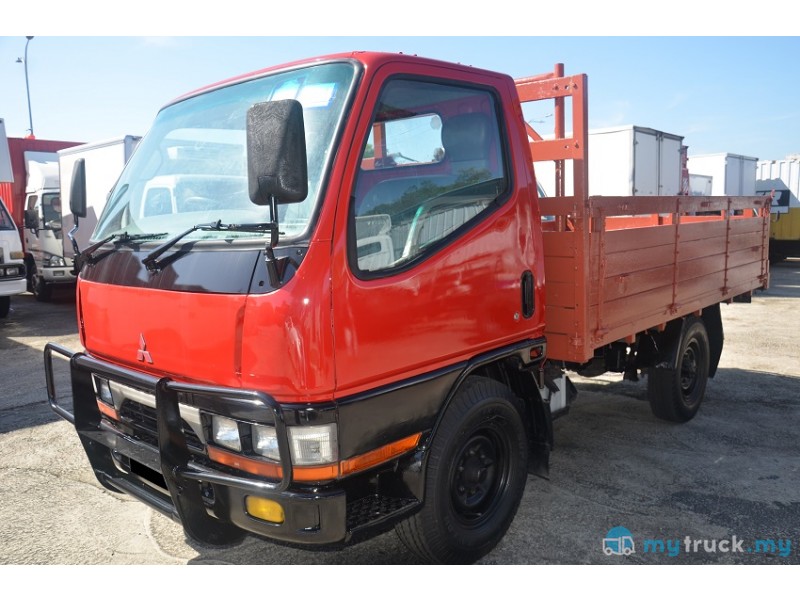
[{"xmin": 536, "ymin": 125, "xmax": 683, "ymax": 196}]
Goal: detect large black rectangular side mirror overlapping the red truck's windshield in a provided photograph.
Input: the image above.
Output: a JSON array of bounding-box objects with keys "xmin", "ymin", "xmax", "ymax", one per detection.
[{"xmin": 247, "ymin": 100, "xmax": 308, "ymax": 206}]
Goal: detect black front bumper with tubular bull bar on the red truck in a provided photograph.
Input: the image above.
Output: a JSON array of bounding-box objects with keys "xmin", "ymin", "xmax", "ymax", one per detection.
[{"xmin": 44, "ymin": 344, "xmax": 420, "ymax": 545}]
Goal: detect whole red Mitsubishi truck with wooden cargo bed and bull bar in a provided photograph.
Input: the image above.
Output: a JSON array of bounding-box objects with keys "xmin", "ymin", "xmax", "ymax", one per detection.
[{"xmin": 45, "ymin": 52, "xmax": 769, "ymax": 563}]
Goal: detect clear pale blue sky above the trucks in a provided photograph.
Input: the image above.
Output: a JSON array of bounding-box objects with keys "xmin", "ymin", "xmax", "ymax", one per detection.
[{"xmin": 0, "ymin": 8, "xmax": 800, "ymax": 166}]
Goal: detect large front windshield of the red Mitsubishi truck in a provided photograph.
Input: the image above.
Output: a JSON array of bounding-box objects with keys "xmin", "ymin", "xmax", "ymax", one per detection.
[{"xmin": 93, "ymin": 63, "xmax": 355, "ymax": 241}]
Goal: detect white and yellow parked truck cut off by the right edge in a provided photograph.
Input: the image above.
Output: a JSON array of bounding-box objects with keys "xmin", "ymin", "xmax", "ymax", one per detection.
[{"xmin": 756, "ymin": 155, "xmax": 800, "ymax": 262}]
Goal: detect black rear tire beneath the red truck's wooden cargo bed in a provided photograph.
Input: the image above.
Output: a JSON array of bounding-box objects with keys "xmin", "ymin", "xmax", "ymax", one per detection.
[{"xmin": 647, "ymin": 317, "xmax": 711, "ymax": 423}]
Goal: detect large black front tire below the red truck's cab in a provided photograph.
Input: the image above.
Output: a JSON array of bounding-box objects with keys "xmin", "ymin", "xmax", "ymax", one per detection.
[{"xmin": 395, "ymin": 377, "xmax": 529, "ymax": 564}]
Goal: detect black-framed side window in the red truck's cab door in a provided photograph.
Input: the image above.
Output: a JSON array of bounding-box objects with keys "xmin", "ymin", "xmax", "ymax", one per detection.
[{"xmin": 350, "ymin": 79, "xmax": 508, "ymax": 273}]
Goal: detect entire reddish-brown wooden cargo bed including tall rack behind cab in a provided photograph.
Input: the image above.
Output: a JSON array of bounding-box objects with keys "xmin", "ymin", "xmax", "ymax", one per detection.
[{"xmin": 516, "ymin": 64, "xmax": 770, "ymax": 363}]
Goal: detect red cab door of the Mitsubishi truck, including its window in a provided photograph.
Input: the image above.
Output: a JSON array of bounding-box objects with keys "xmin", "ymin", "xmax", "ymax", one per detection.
[{"xmin": 332, "ymin": 60, "xmax": 540, "ymax": 400}]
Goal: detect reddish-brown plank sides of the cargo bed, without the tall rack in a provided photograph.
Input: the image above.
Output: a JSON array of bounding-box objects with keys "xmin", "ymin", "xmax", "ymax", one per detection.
[{"xmin": 544, "ymin": 197, "xmax": 769, "ymax": 362}]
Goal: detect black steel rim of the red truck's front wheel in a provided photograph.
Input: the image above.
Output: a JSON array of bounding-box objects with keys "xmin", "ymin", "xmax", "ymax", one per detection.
[{"xmin": 450, "ymin": 429, "xmax": 511, "ymax": 526}]
